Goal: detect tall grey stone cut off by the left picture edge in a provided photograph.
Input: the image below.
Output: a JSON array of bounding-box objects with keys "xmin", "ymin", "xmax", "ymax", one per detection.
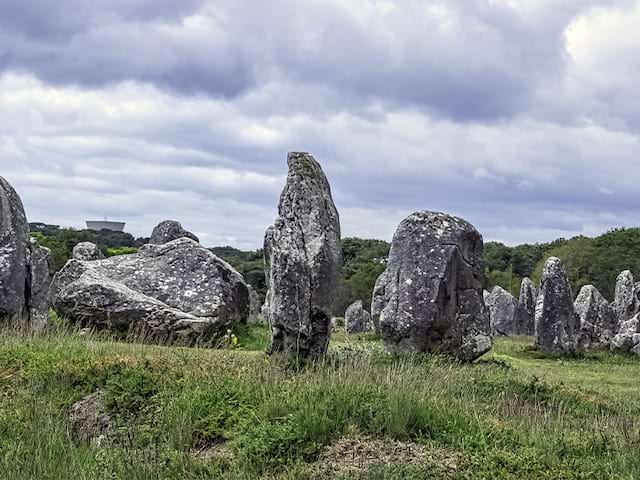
[{"xmin": 0, "ymin": 177, "xmax": 29, "ymax": 319}]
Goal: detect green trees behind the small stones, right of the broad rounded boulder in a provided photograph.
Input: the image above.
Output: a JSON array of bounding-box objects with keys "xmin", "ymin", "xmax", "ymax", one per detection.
[{"xmin": 485, "ymin": 228, "xmax": 640, "ymax": 301}]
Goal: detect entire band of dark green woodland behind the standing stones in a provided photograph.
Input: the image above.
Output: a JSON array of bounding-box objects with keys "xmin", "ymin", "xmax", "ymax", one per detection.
[{"xmin": 31, "ymin": 223, "xmax": 640, "ymax": 315}]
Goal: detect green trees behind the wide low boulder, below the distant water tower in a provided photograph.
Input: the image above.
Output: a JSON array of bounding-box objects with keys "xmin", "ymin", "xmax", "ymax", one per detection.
[{"xmin": 29, "ymin": 223, "xmax": 147, "ymax": 271}]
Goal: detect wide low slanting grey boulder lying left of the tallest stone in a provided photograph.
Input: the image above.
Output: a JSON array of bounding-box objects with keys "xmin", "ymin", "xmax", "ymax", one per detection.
[{"xmin": 50, "ymin": 237, "xmax": 249, "ymax": 344}]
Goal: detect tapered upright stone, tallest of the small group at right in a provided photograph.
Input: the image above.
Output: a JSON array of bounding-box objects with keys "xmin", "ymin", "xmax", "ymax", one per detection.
[{"xmin": 535, "ymin": 257, "xmax": 579, "ymax": 354}]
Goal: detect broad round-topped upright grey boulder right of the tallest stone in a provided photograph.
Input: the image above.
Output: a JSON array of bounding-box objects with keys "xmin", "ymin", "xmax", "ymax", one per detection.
[{"xmin": 380, "ymin": 211, "xmax": 491, "ymax": 361}]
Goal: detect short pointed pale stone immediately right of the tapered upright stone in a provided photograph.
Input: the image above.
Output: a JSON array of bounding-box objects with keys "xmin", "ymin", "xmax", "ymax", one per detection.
[{"xmin": 574, "ymin": 285, "xmax": 617, "ymax": 349}]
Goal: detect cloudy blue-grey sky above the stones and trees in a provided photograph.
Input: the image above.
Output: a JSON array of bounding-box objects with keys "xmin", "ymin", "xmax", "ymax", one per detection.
[{"xmin": 0, "ymin": 0, "xmax": 640, "ymax": 249}]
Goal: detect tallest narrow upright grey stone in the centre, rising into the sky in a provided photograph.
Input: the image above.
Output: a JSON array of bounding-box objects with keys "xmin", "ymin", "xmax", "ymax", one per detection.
[{"xmin": 264, "ymin": 152, "xmax": 342, "ymax": 357}]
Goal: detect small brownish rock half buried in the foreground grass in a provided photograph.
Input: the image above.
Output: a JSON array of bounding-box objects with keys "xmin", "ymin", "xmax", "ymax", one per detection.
[{"xmin": 69, "ymin": 391, "xmax": 115, "ymax": 446}]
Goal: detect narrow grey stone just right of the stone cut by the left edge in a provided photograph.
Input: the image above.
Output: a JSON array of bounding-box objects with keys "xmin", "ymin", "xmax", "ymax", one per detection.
[{"xmin": 27, "ymin": 238, "xmax": 53, "ymax": 328}]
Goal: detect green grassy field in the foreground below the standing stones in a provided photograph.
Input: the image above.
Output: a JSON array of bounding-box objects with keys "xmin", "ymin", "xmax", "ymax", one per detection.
[{"xmin": 0, "ymin": 327, "xmax": 640, "ymax": 480}]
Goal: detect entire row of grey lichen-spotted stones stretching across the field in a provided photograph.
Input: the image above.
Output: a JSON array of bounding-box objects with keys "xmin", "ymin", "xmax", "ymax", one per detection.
[{"xmin": 0, "ymin": 152, "xmax": 640, "ymax": 361}]
